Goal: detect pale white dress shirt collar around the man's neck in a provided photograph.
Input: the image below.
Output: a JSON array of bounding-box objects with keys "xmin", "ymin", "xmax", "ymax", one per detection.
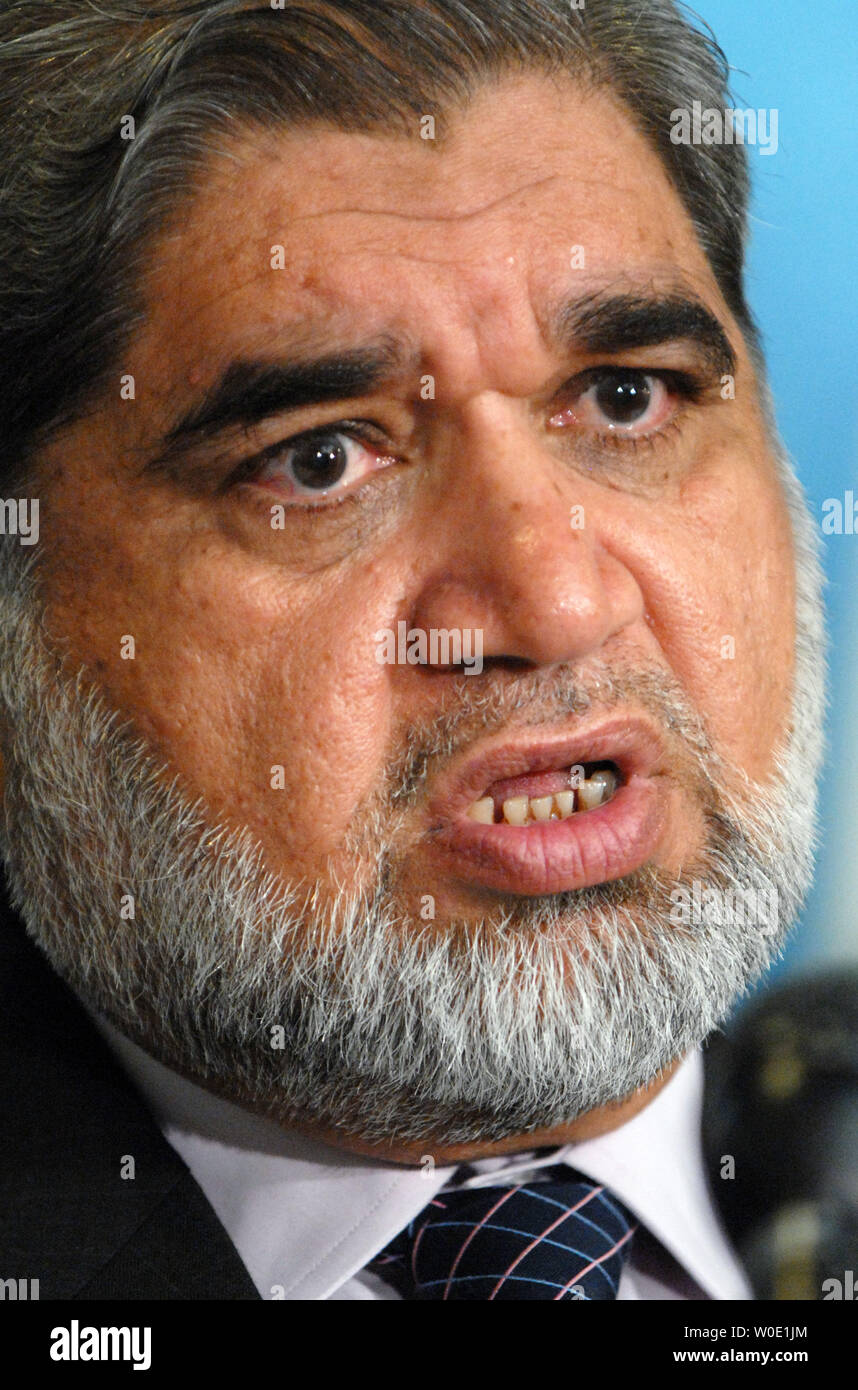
[{"xmin": 93, "ymin": 1016, "xmax": 750, "ymax": 1300}]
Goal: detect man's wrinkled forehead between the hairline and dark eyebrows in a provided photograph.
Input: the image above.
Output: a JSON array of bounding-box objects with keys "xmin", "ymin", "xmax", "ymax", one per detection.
[{"xmin": 139, "ymin": 76, "xmax": 729, "ymax": 380}]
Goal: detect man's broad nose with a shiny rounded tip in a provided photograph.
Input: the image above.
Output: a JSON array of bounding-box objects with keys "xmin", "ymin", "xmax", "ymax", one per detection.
[{"xmin": 412, "ymin": 403, "xmax": 644, "ymax": 670}]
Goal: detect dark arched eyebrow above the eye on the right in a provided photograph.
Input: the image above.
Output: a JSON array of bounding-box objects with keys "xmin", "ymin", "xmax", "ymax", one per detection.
[{"xmin": 551, "ymin": 295, "xmax": 736, "ymax": 375}]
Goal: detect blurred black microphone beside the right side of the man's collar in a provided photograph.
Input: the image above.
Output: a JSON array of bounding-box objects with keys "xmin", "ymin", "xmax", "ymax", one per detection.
[{"xmin": 702, "ymin": 969, "xmax": 858, "ymax": 1301}]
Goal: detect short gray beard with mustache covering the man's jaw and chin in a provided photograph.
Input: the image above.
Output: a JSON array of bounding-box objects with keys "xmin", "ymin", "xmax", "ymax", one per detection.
[{"xmin": 0, "ymin": 453, "xmax": 823, "ymax": 1145}]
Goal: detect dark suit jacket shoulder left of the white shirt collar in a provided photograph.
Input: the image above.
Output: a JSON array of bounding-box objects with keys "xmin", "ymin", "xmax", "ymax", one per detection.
[{"xmin": 0, "ymin": 894, "xmax": 259, "ymax": 1300}]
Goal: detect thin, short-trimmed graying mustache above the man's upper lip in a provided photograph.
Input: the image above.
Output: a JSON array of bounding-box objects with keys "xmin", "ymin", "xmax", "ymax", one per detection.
[{"xmin": 382, "ymin": 659, "xmax": 729, "ymax": 810}]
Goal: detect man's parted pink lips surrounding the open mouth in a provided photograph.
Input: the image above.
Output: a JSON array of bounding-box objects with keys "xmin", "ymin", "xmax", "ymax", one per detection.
[{"xmin": 428, "ymin": 714, "xmax": 667, "ymax": 897}]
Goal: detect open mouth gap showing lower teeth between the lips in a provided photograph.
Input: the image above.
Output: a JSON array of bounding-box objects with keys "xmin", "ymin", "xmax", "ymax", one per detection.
[{"xmin": 467, "ymin": 762, "xmax": 623, "ymax": 828}]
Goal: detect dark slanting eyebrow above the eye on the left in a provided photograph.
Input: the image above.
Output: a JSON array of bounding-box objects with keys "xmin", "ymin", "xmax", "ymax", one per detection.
[{"xmin": 145, "ymin": 343, "xmax": 402, "ymax": 473}]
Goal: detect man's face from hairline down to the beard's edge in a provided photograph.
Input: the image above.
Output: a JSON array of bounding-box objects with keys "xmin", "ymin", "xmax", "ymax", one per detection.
[{"xmin": 16, "ymin": 76, "xmax": 812, "ymax": 1150}]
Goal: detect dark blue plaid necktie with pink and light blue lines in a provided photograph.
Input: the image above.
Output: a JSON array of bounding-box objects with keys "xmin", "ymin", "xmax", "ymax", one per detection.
[{"xmin": 367, "ymin": 1165, "xmax": 637, "ymax": 1302}]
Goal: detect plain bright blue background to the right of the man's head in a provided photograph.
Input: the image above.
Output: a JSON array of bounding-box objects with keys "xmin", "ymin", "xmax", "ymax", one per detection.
[{"xmin": 693, "ymin": 0, "xmax": 858, "ymax": 973}]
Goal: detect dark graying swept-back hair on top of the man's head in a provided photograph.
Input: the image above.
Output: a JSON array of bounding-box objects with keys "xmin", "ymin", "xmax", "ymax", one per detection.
[{"xmin": 0, "ymin": 0, "xmax": 759, "ymax": 491}]
